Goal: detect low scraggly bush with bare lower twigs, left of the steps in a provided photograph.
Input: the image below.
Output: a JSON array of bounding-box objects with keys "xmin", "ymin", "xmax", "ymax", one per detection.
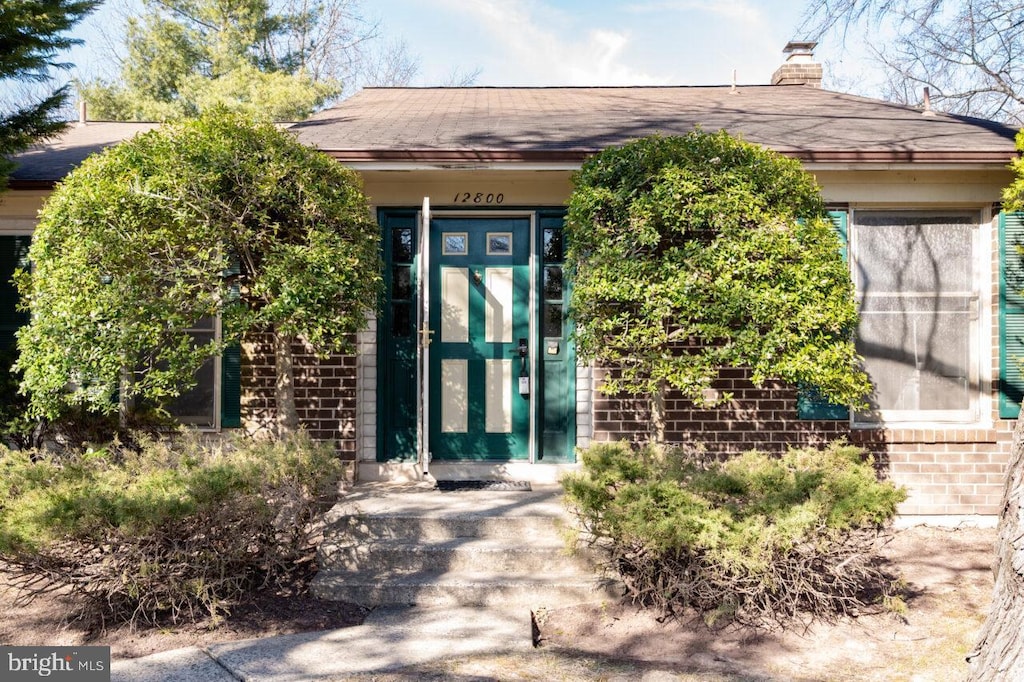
[{"xmin": 0, "ymin": 432, "xmax": 342, "ymax": 623}]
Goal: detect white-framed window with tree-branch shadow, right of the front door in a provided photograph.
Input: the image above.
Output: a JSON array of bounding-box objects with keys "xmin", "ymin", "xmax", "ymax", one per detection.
[{"xmin": 850, "ymin": 210, "xmax": 980, "ymax": 423}]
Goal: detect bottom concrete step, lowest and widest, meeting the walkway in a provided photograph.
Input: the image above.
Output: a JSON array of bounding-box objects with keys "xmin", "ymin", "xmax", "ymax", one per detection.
[{"xmin": 310, "ymin": 572, "xmax": 622, "ymax": 609}]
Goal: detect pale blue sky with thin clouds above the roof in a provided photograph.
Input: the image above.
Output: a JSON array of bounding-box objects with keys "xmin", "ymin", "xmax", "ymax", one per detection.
[{"xmin": 61, "ymin": 0, "xmax": 872, "ymax": 91}]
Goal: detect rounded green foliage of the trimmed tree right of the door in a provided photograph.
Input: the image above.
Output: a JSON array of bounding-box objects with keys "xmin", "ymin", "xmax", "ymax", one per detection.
[{"xmin": 566, "ymin": 131, "xmax": 869, "ymax": 403}]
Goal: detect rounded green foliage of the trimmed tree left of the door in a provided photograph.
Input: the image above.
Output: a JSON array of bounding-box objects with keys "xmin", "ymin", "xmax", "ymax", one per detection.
[{"xmin": 17, "ymin": 111, "xmax": 382, "ymax": 417}]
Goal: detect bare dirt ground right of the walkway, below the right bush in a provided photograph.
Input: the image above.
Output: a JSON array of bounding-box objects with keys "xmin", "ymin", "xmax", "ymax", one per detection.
[{"xmin": 541, "ymin": 526, "xmax": 996, "ymax": 682}]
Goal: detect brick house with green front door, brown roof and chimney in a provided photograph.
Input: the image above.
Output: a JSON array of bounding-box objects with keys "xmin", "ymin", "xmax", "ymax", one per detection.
[{"xmin": 0, "ymin": 54, "xmax": 1024, "ymax": 518}]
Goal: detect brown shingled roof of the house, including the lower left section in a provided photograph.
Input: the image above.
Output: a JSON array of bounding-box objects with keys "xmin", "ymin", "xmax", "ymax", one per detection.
[{"xmin": 10, "ymin": 85, "xmax": 1017, "ymax": 187}]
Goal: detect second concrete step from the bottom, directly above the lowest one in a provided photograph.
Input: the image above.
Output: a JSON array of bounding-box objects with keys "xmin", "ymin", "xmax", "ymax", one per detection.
[{"xmin": 319, "ymin": 537, "xmax": 596, "ymax": 574}]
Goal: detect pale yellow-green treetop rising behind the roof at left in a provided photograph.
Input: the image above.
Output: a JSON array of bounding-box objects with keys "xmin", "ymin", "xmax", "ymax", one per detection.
[{"xmin": 79, "ymin": 0, "xmax": 345, "ymax": 121}]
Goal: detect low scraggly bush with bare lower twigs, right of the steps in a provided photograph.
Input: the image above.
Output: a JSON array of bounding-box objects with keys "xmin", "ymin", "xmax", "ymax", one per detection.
[{"xmin": 563, "ymin": 443, "xmax": 906, "ymax": 628}]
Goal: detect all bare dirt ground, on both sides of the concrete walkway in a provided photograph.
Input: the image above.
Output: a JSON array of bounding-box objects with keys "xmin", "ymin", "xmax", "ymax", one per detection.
[{"xmin": 0, "ymin": 527, "xmax": 995, "ymax": 682}]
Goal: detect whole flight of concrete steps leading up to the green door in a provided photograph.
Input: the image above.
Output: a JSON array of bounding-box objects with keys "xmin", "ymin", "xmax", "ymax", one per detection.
[{"xmin": 311, "ymin": 485, "xmax": 622, "ymax": 607}]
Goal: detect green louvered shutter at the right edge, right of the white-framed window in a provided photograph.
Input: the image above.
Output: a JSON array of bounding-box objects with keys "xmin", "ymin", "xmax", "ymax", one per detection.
[{"xmin": 998, "ymin": 212, "xmax": 1024, "ymax": 419}]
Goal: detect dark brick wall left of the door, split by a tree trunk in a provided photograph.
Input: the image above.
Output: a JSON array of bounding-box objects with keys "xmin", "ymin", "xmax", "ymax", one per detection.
[{"xmin": 242, "ymin": 329, "xmax": 357, "ymax": 460}]
